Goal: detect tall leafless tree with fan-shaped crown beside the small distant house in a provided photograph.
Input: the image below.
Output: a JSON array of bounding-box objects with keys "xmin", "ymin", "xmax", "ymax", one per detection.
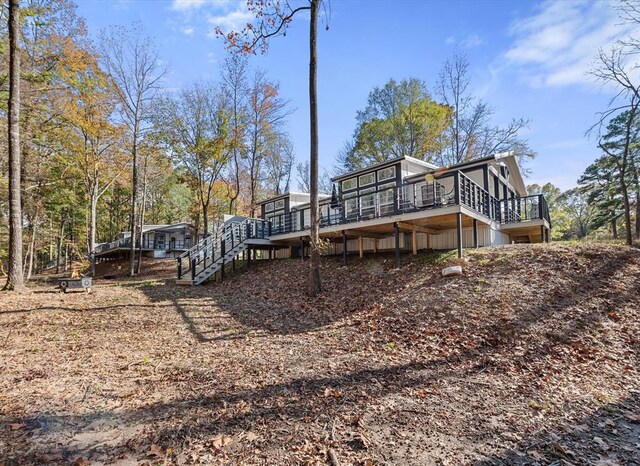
[{"xmin": 100, "ymin": 23, "xmax": 166, "ymax": 276}]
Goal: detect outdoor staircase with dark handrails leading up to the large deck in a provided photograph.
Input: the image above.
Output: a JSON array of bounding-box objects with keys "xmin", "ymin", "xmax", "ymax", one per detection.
[{"xmin": 176, "ymin": 218, "xmax": 269, "ymax": 285}]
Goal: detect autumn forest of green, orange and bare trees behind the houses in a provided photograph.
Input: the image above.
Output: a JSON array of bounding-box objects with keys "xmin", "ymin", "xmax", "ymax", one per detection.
[{"xmin": 0, "ymin": 0, "xmax": 640, "ymax": 288}]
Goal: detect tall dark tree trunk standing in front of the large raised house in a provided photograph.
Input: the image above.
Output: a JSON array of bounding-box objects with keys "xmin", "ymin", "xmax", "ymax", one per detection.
[{"xmin": 308, "ymin": 0, "xmax": 322, "ymax": 296}]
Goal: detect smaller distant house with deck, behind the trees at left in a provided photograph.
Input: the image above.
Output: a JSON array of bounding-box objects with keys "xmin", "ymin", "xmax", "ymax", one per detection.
[{"xmin": 94, "ymin": 222, "xmax": 200, "ymax": 261}]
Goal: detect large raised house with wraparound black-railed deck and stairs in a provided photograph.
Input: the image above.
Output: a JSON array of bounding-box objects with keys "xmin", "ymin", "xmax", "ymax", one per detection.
[{"xmin": 178, "ymin": 153, "xmax": 551, "ymax": 284}]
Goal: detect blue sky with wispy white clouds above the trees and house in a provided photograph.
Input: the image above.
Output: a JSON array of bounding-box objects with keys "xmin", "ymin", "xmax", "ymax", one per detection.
[{"xmin": 77, "ymin": 0, "xmax": 629, "ymax": 189}]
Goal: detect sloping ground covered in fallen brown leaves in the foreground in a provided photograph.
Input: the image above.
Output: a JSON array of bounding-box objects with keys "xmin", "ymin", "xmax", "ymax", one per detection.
[{"xmin": 0, "ymin": 244, "xmax": 640, "ymax": 465}]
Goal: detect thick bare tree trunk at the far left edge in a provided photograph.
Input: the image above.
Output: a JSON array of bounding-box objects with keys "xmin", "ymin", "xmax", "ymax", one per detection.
[{"xmin": 4, "ymin": 0, "xmax": 25, "ymax": 292}]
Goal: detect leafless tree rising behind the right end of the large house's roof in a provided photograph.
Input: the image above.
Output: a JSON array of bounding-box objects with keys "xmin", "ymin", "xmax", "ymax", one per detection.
[{"xmin": 436, "ymin": 54, "xmax": 535, "ymax": 165}]
